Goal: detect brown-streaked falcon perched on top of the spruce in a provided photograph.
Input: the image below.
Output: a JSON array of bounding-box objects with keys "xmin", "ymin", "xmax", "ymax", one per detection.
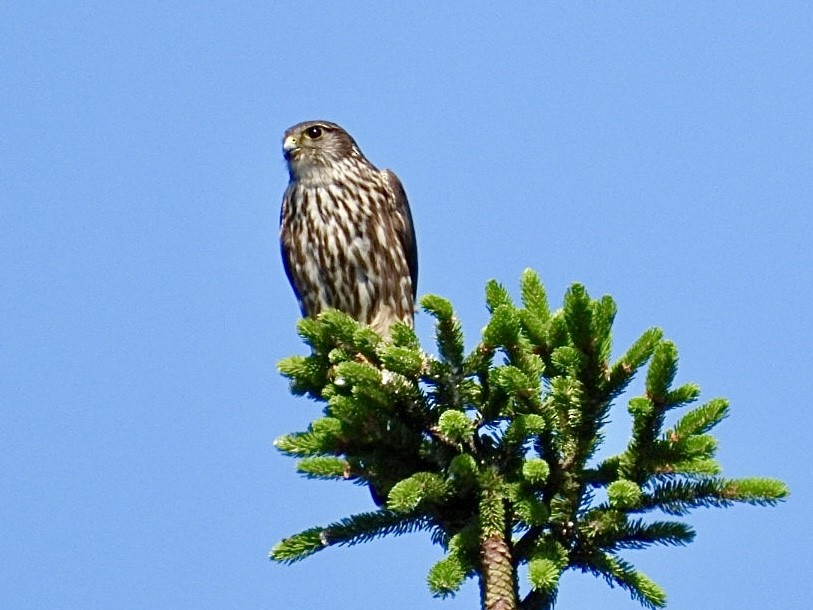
[{"xmin": 280, "ymin": 121, "xmax": 418, "ymax": 337}]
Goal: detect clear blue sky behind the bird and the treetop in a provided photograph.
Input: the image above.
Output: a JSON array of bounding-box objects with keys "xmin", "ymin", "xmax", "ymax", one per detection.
[{"xmin": 0, "ymin": 1, "xmax": 813, "ymax": 610}]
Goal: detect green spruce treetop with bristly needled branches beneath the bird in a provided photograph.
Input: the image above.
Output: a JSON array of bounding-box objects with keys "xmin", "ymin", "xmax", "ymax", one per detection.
[{"xmin": 271, "ymin": 270, "xmax": 788, "ymax": 610}]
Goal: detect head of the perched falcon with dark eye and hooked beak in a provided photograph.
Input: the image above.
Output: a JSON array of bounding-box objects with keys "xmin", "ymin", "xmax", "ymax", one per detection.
[{"xmin": 282, "ymin": 121, "xmax": 361, "ymax": 177}]
